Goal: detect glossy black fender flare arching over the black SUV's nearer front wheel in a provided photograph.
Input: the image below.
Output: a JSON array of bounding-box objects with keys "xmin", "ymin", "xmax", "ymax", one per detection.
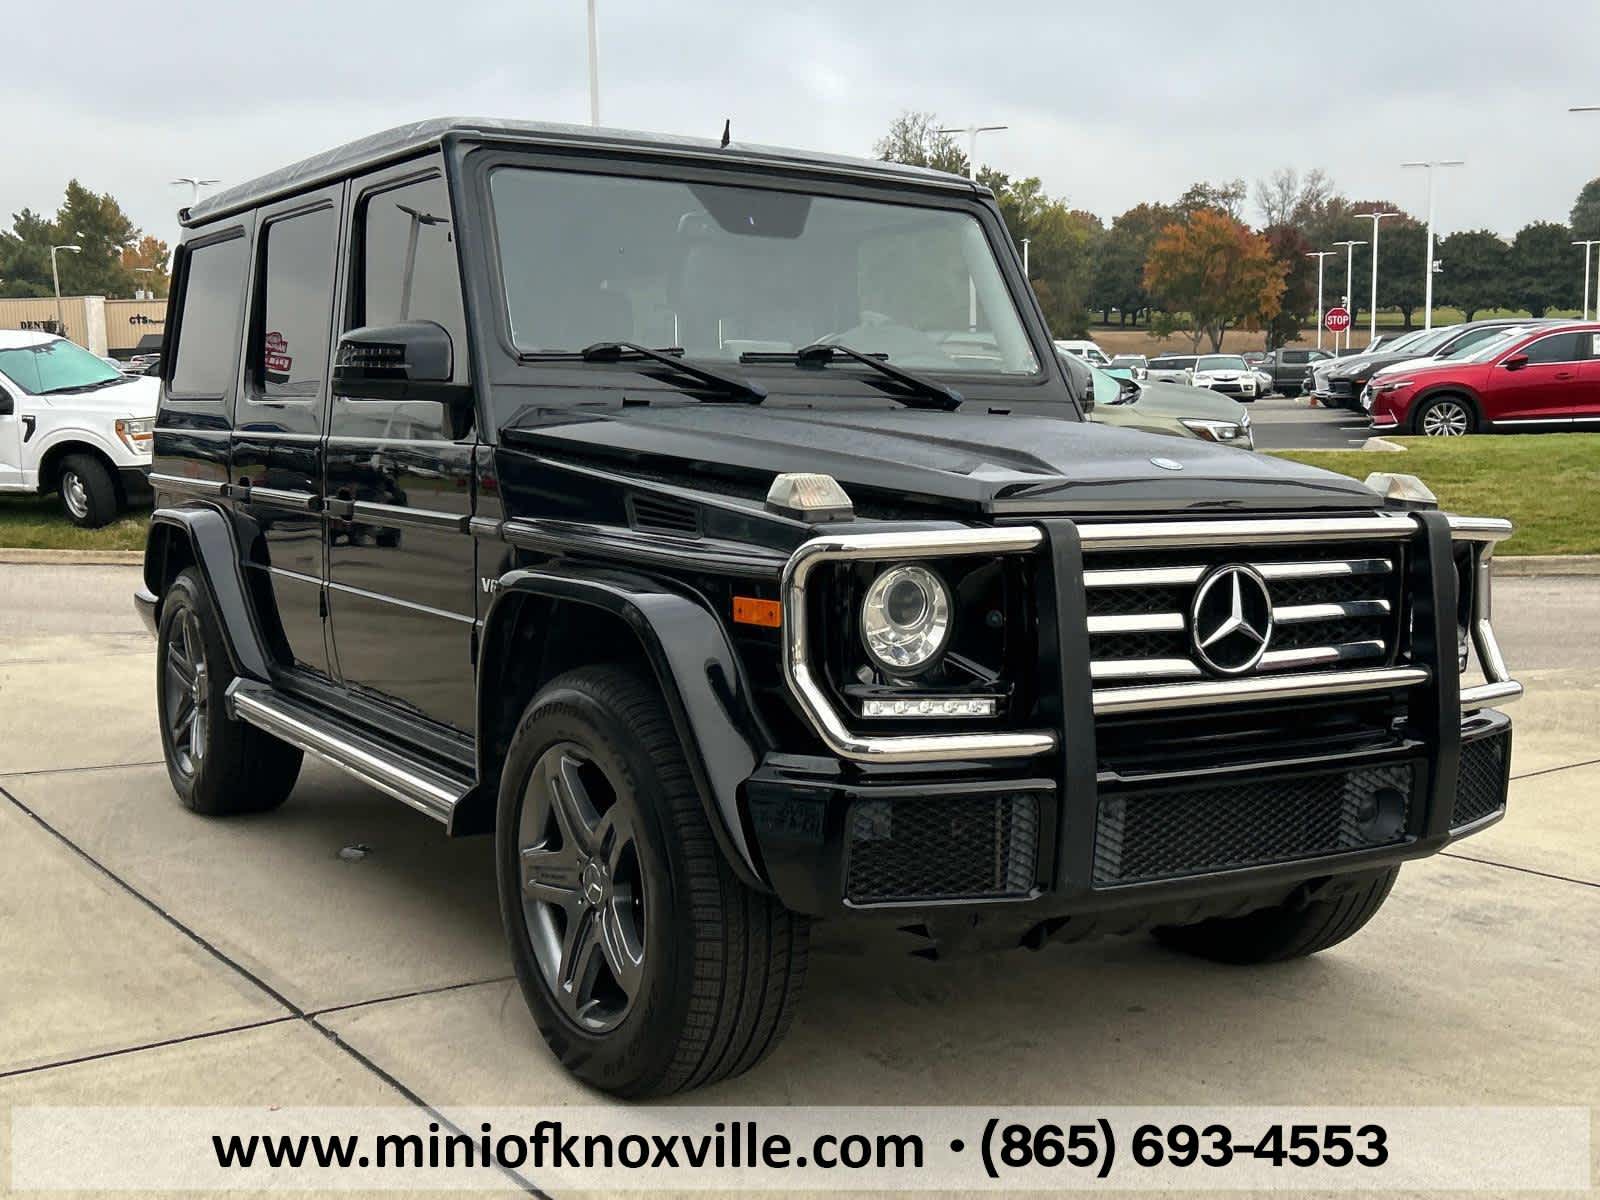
[{"xmin": 478, "ymin": 566, "xmax": 770, "ymax": 890}]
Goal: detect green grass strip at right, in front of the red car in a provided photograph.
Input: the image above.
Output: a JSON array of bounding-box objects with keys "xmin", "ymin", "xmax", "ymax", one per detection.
[{"xmin": 1280, "ymin": 434, "xmax": 1600, "ymax": 554}]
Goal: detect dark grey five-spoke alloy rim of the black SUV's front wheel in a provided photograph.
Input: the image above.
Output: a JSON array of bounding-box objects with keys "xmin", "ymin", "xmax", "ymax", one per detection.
[{"xmin": 517, "ymin": 742, "xmax": 648, "ymax": 1034}]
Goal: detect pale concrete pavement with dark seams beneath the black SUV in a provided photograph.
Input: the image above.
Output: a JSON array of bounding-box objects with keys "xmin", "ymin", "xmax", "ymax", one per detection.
[{"xmin": 0, "ymin": 566, "xmax": 1600, "ymax": 1178}]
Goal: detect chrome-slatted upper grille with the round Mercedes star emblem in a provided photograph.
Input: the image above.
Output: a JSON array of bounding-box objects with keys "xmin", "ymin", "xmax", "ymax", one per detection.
[{"xmin": 1083, "ymin": 541, "xmax": 1405, "ymax": 690}]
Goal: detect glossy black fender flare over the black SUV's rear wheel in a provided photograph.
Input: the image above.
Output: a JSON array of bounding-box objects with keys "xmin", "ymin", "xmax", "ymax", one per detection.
[{"xmin": 144, "ymin": 504, "xmax": 272, "ymax": 683}]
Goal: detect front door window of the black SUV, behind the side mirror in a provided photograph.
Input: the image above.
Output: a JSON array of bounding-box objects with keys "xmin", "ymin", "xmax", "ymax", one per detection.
[{"xmin": 352, "ymin": 178, "xmax": 467, "ymax": 384}]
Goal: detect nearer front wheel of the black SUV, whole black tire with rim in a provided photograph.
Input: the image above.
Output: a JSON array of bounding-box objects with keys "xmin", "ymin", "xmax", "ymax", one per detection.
[{"xmin": 496, "ymin": 667, "xmax": 810, "ymax": 1096}]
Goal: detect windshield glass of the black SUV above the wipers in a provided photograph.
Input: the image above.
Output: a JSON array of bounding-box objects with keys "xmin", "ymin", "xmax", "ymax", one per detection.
[{"xmin": 490, "ymin": 166, "xmax": 1038, "ymax": 374}]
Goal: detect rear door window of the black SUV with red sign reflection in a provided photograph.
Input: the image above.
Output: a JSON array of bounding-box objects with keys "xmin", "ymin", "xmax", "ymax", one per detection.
[{"xmin": 250, "ymin": 208, "xmax": 339, "ymax": 403}]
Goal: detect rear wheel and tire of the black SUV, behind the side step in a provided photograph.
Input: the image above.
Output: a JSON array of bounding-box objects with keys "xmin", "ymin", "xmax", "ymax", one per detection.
[{"xmin": 155, "ymin": 566, "xmax": 302, "ymax": 816}]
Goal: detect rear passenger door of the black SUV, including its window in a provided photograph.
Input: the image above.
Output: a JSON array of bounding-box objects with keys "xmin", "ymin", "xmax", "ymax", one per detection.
[{"xmin": 232, "ymin": 184, "xmax": 344, "ymax": 675}]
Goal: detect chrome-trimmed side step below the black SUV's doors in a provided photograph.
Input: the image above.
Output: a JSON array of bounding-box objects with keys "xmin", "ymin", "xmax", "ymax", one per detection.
[{"xmin": 227, "ymin": 680, "xmax": 472, "ymax": 824}]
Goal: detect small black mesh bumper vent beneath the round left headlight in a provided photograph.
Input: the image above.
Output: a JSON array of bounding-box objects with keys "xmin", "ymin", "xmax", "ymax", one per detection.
[{"xmin": 845, "ymin": 792, "xmax": 1038, "ymax": 904}]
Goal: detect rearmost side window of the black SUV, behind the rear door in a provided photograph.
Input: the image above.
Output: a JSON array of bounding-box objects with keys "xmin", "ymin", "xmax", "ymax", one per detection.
[{"xmin": 168, "ymin": 237, "xmax": 250, "ymax": 400}]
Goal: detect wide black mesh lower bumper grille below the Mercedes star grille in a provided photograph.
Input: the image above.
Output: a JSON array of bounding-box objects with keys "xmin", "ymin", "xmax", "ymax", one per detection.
[{"xmin": 1094, "ymin": 763, "xmax": 1413, "ymax": 885}]
